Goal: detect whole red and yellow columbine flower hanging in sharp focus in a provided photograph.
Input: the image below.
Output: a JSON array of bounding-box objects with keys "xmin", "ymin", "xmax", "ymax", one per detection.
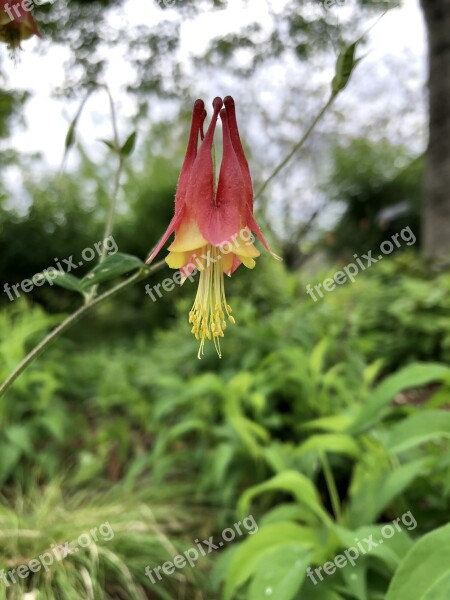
[{"xmin": 147, "ymin": 96, "xmax": 275, "ymax": 358}]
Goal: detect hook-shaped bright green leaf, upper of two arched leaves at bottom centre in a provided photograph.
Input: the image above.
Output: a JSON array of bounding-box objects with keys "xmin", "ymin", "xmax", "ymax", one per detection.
[{"xmin": 239, "ymin": 470, "xmax": 331, "ymax": 522}]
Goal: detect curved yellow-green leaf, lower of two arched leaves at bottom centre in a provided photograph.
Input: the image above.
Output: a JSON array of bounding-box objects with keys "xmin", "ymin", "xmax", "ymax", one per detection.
[{"xmin": 224, "ymin": 521, "xmax": 317, "ymax": 600}]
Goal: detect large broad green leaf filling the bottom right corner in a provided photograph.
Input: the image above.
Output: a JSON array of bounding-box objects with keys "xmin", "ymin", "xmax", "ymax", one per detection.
[{"xmin": 386, "ymin": 524, "xmax": 450, "ymax": 600}]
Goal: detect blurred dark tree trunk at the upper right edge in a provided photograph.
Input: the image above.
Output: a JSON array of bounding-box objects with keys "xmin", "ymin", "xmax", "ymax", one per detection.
[{"xmin": 421, "ymin": 0, "xmax": 450, "ymax": 260}]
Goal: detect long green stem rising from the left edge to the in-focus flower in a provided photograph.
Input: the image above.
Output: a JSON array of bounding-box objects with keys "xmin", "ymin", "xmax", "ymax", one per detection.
[{"xmin": 0, "ymin": 260, "xmax": 166, "ymax": 397}]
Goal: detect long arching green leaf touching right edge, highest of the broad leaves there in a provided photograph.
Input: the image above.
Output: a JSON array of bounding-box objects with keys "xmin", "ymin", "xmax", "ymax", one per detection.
[{"xmin": 350, "ymin": 363, "xmax": 450, "ymax": 433}]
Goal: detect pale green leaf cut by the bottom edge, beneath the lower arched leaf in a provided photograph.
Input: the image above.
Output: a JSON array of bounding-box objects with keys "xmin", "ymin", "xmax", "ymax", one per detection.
[{"xmin": 247, "ymin": 543, "xmax": 311, "ymax": 600}]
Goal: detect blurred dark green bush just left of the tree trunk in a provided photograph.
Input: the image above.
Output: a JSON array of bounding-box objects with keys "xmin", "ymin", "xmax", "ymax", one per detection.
[{"xmin": 324, "ymin": 138, "xmax": 424, "ymax": 258}]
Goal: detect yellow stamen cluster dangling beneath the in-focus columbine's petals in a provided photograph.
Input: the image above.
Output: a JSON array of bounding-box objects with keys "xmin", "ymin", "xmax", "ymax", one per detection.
[{"xmin": 189, "ymin": 245, "xmax": 235, "ymax": 358}]
